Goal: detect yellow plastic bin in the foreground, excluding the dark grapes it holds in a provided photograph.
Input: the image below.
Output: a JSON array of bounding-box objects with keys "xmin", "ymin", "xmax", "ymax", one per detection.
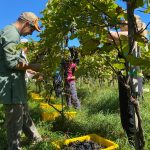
[{"xmin": 52, "ymin": 134, "xmax": 119, "ymax": 150}]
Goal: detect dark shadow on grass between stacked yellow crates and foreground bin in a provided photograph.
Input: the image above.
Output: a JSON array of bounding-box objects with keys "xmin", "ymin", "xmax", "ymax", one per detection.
[{"xmin": 51, "ymin": 117, "xmax": 116, "ymax": 138}]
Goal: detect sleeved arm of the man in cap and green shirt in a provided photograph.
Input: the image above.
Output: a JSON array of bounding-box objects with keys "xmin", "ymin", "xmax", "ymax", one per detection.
[{"xmin": 1, "ymin": 30, "xmax": 40, "ymax": 71}]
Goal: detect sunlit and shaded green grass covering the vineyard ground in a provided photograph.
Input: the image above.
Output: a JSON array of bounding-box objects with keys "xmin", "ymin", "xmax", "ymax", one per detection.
[{"xmin": 0, "ymin": 80, "xmax": 150, "ymax": 150}]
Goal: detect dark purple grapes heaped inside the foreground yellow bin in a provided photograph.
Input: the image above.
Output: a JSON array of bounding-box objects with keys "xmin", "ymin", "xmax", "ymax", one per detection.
[{"xmin": 62, "ymin": 140, "xmax": 106, "ymax": 150}]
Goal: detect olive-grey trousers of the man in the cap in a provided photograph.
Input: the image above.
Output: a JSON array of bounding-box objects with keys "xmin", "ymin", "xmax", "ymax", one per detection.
[{"xmin": 4, "ymin": 104, "xmax": 41, "ymax": 150}]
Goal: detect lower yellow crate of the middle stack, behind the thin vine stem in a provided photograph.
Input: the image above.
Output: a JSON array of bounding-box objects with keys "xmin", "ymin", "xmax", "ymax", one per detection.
[{"xmin": 41, "ymin": 111, "xmax": 76, "ymax": 121}]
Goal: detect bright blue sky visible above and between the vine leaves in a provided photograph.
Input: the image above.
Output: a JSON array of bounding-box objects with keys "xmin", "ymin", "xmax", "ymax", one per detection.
[{"xmin": 0, "ymin": 0, "xmax": 150, "ymax": 45}]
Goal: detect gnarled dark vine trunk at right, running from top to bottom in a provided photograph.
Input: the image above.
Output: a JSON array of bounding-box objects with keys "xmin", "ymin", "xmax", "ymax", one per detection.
[{"xmin": 127, "ymin": 0, "xmax": 145, "ymax": 150}]
